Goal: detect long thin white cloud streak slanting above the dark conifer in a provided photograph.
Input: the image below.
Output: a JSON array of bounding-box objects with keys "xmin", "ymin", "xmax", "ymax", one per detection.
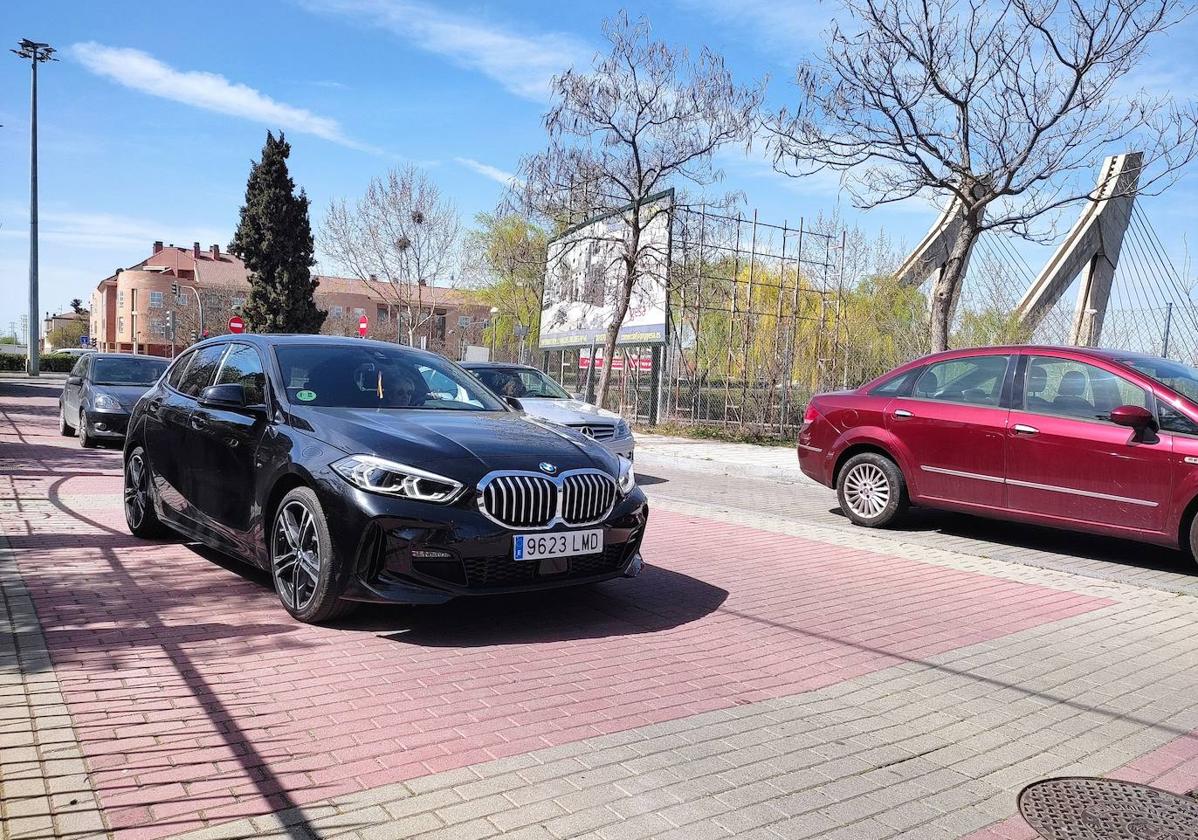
[{"xmin": 71, "ymin": 41, "xmax": 371, "ymax": 151}]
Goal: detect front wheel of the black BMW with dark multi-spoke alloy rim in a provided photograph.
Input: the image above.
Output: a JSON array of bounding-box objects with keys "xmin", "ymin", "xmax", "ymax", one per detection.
[{"xmin": 267, "ymin": 487, "xmax": 357, "ymax": 624}]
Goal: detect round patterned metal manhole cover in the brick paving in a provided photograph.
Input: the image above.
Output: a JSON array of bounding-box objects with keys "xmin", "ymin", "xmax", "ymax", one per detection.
[{"xmin": 1019, "ymin": 779, "xmax": 1198, "ymax": 840}]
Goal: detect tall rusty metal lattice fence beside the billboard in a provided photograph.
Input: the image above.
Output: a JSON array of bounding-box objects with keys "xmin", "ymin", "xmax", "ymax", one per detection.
[{"xmin": 547, "ymin": 205, "xmax": 853, "ymax": 435}]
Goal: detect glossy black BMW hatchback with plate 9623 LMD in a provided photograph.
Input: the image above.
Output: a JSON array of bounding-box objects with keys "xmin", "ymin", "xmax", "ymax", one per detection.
[{"xmin": 125, "ymin": 336, "xmax": 648, "ymax": 622}]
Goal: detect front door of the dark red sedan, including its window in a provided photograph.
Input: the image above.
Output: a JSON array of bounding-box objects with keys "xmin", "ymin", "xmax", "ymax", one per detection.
[{"xmin": 1006, "ymin": 355, "xmax": 1173, "ymax": 532}]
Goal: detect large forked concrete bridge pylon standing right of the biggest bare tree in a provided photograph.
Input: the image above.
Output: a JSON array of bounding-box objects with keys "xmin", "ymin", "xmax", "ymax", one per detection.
[{"xmin": 1016, "ymin": 152, "xmax": 1144, "ymax": 346}]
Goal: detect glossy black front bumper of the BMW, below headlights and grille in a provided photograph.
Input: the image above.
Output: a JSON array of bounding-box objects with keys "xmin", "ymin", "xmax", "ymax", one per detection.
[{"xmin": 325, "ymin": 483, "xmax": 648, "ymax": 604}]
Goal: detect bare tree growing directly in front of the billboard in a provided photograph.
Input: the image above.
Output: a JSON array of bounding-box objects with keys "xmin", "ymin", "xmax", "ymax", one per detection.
[{"xmin": 520, "ymin": 13, "xmax": 761, "ymax": 403}]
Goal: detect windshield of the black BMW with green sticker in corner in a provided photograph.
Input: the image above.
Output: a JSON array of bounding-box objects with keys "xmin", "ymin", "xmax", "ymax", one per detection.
[{"xmin": 274, "ymin": 345, "xmax": 506, "ymax": 411}]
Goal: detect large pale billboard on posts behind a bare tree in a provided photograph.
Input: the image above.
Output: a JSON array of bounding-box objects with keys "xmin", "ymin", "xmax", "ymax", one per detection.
[{"xmin": 540, "ymin": 191, "xmax": 673, "ymax": 350}]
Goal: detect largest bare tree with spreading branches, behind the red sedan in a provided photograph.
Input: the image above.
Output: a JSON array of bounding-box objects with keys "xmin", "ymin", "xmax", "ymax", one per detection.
[{"xmin": 768, "ymin": 0, "xmax": 1198, "ymax": 350}]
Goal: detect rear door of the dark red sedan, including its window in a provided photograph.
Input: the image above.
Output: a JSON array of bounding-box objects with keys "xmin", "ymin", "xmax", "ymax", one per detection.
[{"xmin": 885, "ymin": 353, "xmax": 1014, "ymax": 508}]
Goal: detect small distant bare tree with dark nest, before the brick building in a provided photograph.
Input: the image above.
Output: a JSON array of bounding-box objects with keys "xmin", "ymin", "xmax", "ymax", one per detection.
[{"xmin": 321, "ymin": 165, "xmax": 461, "ymax": 344}]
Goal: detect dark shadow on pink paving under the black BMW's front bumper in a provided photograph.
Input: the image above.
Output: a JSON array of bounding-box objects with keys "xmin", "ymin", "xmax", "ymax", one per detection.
[{"xmin": 340, "ymin": 566, "xmax": 728, "ymax": 647}]
